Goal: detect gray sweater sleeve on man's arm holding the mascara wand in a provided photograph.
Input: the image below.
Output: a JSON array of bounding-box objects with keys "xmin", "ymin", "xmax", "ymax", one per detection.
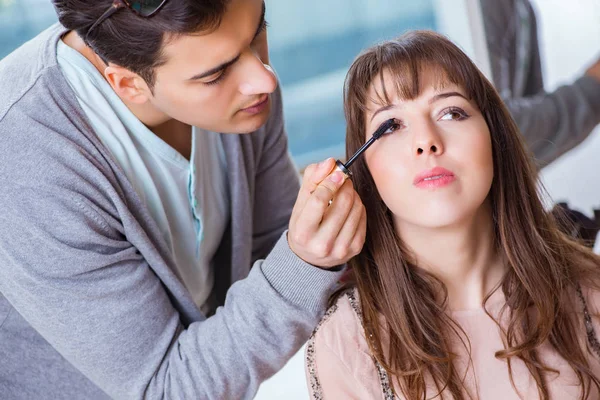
[{"xmin": 0, "ymin": 83, "xmax": 340, "ymax": 399}]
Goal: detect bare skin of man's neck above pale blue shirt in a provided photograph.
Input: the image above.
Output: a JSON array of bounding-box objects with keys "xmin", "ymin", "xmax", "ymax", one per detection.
[{"xmin": 62, "ymin": 31, "xmax": 192, "ymax": 160}]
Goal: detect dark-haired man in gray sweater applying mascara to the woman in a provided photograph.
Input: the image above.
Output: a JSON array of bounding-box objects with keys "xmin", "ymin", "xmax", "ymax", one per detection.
[{"xmin": 0, "ymin": 0, "xmax": 366, "ymax": 399}]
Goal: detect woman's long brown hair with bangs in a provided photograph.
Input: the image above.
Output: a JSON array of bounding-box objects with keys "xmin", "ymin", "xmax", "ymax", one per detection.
[{"xmin": 344, "ymin": 31, "xmax": 600, "ymax": 399}]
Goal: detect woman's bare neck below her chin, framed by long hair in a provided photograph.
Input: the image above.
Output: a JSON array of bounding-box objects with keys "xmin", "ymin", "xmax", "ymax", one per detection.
[{"xmin": 396, "ymin": 202, "xmax": 506, "ymax": 310}]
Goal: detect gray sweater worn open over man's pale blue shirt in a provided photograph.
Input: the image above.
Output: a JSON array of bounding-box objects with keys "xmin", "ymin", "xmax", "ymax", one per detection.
[{"xmin": 0, "ymin": 25, "xmax": 339, "ymax": 399}]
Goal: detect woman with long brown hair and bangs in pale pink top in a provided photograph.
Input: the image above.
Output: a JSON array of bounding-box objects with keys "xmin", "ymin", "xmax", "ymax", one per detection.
[{"xmin": 306, "ymin": 31, "xmax": 600, "ymax": 400}]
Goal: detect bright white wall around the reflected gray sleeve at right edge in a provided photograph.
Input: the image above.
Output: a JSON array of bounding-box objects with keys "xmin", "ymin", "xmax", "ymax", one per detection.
[{"xmin": 531, "ymin": 0, "xmax": 600, "ymax": 215}]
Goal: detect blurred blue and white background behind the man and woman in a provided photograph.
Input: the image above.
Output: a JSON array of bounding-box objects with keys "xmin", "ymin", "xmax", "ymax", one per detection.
[{"xmin": 0, "ymin": 0, "xmax": 600, "ymax": 400}]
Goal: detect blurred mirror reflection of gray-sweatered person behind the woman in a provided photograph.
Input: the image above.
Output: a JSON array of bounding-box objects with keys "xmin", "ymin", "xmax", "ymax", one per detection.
[{"xmin": 480, "ymin": 0, "xmax": 600, "ymax": 165}]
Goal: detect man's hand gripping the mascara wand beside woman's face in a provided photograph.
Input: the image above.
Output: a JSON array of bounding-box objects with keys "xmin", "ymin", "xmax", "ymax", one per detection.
[{"xmin": 288, "ymin": 158, "xmax": 367, "ymax": 268}]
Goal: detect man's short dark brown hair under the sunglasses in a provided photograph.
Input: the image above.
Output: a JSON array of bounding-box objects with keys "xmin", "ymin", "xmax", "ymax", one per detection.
[{"xmin": 52, "ymin": 0, "xmax": 229, "ymax": 89}]
